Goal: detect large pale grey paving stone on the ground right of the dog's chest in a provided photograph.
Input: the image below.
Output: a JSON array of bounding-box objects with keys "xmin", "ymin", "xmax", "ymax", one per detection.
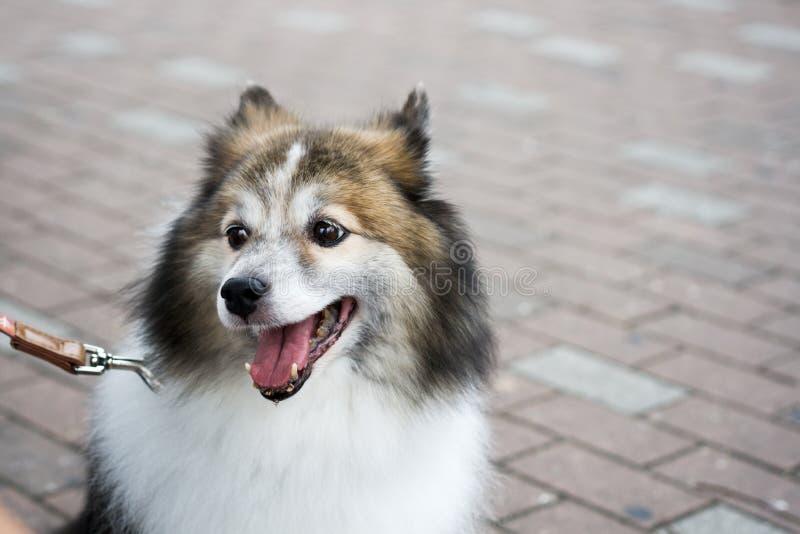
[{"xmin": 511, "ymin": 345, "xmax": 685, "ymax": 414}]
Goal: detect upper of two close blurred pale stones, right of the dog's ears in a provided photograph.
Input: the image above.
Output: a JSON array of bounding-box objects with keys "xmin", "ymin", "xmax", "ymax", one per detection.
[{"xmin": 620, "ymin": 139, "xmax": 726, "ymax": 177}]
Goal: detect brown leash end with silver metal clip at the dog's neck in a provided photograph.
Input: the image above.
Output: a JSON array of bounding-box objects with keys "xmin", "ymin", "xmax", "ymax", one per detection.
[{"xmin": 0, "ymin": 313, "xmax": 161, "ymax": 393}]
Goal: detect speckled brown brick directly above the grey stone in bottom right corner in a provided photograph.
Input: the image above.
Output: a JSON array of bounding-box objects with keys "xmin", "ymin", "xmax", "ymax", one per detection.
[{"xmin": 657, "ymin": 447, "xmax": 800, "ymax": 515}]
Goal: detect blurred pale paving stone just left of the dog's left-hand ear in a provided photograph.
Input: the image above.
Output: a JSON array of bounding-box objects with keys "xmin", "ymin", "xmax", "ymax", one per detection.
[{"xmin": 112, "ymin": 108, "xmax": 205, "ymax": 145}]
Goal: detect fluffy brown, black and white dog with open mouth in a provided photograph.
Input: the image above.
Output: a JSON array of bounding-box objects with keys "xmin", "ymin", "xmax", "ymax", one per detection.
[{"xmin": 73, "ymin": 85, "xmax": 494, "ymax": 534}]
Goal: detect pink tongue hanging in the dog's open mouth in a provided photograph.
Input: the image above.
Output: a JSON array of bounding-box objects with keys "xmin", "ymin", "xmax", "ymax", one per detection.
[{"xmin": 250, "ymin": 314, "xmax": 317, "ymax": 389}]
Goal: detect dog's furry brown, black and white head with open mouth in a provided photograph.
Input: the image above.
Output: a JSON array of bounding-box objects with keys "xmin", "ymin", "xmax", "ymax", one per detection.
[{"xmin": 139, "ymin": 86, "xmax": 491, "ymax": 401}]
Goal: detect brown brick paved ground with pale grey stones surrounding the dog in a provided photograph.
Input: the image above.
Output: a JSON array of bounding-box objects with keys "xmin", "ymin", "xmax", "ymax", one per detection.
[{"xmin": 0, "ymin": 0, "xmax": 800, "ymax": 534}]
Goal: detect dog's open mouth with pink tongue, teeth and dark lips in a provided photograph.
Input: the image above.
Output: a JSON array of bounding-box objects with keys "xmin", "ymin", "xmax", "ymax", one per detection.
[{"xmin": 245, "ymin": 297, "xmax": 356, "ymax": 402}]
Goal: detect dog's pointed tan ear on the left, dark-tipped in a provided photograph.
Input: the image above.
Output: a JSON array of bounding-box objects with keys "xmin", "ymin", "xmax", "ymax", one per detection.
[{"xmin": 206, "ymin": 84, "xmax": 300, "ymax": 178}]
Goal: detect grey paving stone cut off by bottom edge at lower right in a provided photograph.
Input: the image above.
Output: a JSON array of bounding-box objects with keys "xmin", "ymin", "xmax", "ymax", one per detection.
[{"xmin": 658, "ymin": 504, "xmax": 788, "ymax": 534}]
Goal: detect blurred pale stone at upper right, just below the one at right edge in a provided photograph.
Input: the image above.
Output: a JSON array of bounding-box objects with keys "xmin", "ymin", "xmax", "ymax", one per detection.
[{"xmin": 676, "ymin": 50, "xmax": 772, "ymax": 84}]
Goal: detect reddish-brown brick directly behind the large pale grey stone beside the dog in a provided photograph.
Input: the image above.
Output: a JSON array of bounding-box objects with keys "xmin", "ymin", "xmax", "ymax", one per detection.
[{"xmin": 522, "ymin": 309, "xmax": 674, "ymax": 364}]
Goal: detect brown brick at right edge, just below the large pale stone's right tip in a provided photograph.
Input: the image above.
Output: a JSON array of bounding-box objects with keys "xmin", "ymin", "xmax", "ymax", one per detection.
[{"xmin": 653, "ymin": 398, "xmax": 800, "ymax": 470}]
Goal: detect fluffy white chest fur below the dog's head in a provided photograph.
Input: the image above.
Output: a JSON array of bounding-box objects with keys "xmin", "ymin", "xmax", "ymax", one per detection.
[{"xmin": 94, "ymin": 365, "xmax": 487, "ymax": 534}]
